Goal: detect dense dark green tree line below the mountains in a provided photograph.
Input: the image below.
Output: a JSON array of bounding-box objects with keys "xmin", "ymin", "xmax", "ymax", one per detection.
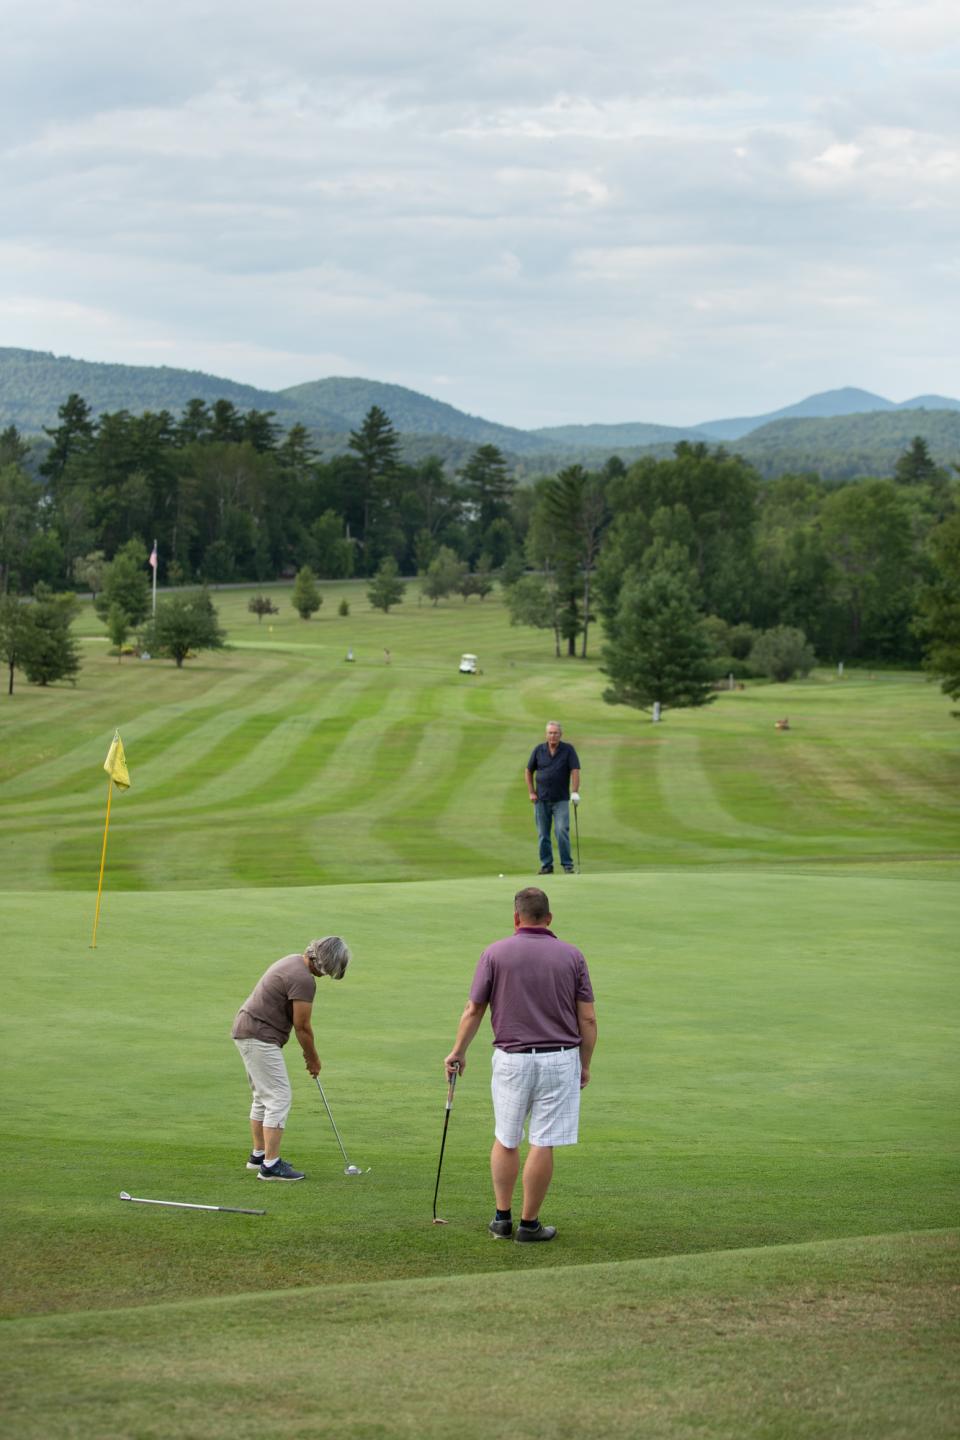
[{"xmin": 0, "ymin": 395, "xmax": 960, "ymax": 714}]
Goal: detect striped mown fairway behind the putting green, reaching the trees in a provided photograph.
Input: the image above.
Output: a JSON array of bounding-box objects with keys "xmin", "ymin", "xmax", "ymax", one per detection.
[{"xmin": 0, "ymin": 583, "xmax": 960, "ymax": 891}]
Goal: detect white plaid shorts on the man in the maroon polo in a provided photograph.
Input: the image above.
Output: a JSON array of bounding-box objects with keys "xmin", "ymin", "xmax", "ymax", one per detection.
[{"xmin": 491, "ymin": 1047, "xmax": 580, "ymax": 1151}]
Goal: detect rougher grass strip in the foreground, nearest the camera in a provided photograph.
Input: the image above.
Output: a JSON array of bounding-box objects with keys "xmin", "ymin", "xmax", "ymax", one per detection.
[{"xmin": 0, "ymin": 1231, "xmax": 960, "ymax": 1440}]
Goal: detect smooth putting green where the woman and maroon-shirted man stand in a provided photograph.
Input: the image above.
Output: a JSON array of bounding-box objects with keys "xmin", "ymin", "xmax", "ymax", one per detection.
[{"xmin": 3, "ymin": 873, "xmax": 959, "ymax": 1312}]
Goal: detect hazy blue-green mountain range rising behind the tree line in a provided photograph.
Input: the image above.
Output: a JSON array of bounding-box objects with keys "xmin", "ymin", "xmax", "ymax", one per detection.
[{"xmin": 0, "ymin": 347, "xmax": 960, "ymax": 475}]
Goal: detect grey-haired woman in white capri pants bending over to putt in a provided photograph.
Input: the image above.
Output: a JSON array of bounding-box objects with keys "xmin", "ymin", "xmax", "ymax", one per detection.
[{"xmin": 230, "ymin": 935, "xmax": 350, "ymax": 1179}]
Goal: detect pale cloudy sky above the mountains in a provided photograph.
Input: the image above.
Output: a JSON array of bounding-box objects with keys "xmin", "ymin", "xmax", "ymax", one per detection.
[{"xmin": 0, "ymin": 0, "xmax": 960, "ymax": 428}]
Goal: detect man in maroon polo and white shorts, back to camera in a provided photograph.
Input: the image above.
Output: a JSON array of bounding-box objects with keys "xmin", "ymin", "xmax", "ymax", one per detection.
[{"xmin": 445, "ymin": 886, "xmax": 597, "ymax": 1241}]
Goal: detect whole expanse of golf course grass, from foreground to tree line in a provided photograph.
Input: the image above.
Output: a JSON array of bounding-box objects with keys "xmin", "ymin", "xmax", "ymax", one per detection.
[{"xmin": 0, "ymin": 585, "xmax": 960, "ymax": 1440}]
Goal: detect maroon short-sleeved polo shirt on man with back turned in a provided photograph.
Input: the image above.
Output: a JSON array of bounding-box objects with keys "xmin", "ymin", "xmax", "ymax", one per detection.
[{"xmin": 471, "ymin": 926, "xmax": 593, "ymax": 1050}]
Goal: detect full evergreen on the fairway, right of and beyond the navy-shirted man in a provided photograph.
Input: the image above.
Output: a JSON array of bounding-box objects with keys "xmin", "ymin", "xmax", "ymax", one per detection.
[{"xmin": 602, "ymin": 567, "xmax": 715, "ymax": 719}]
